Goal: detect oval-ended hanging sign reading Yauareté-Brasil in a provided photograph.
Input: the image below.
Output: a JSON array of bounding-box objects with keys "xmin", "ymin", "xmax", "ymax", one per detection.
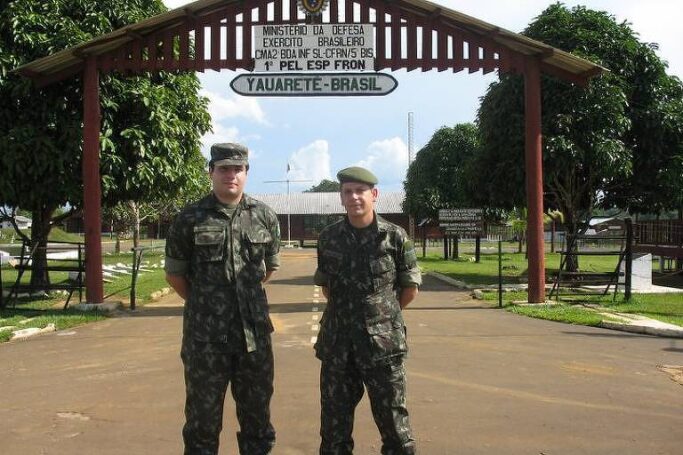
[{"xmin": 230, "ymin": 73, "xmax": 398, "ymax": 96}]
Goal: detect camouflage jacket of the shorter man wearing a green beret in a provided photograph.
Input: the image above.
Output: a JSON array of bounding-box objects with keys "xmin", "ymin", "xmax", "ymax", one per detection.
[{"xmin": 315, "ymin": 215, "xmax": 421, "ymax": 365}]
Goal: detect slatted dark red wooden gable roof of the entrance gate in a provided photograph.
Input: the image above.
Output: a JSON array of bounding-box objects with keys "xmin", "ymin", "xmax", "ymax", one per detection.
[{"xmin": 16, "ymin": 0, "xmax": 604, "ymax": 85}]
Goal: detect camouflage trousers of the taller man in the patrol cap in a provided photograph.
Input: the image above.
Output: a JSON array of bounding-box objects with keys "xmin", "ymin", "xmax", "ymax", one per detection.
[{"xmin": 181, "ymin": 340, "xmax": 275, "ymax": 455}]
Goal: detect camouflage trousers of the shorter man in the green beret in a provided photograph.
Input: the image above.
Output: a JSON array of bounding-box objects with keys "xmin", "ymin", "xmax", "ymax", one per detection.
[{"xmin": 320, "ymin": 356, "xmax": 417, "ymax": 455}]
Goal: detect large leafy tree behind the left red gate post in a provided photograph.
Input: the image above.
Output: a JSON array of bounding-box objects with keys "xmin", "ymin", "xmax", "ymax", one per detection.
[{"xmin": 0, "ymin": 0, "xmax": 210, "ymax": 285}]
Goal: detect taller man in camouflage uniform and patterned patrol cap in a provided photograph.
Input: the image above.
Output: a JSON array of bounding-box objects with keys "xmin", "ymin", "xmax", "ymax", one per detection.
[{"xmin": 165, "ymin": 144, "xmax": 280, "ymax": 455}]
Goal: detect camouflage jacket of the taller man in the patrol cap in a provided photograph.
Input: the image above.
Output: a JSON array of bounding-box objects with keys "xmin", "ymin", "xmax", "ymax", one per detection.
[{"xmin": 165, "ymin": 193, "xmax": 280, "ymax": 352}]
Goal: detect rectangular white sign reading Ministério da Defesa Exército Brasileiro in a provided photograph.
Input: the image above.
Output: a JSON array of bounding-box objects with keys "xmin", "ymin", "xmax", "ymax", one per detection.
[{"xmin": 254, "ymin": 24, "xmax": 375, "ymax": 72}]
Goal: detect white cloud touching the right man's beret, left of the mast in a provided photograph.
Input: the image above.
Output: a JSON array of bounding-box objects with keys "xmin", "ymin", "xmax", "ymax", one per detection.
[{"xmin": 358, "ymin": 137, "xmax": 408, "ymax": 187}]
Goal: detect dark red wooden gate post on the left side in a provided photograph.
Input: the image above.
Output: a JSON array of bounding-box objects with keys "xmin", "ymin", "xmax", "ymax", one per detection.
[{"xmin": 82, "ymin": 57, "xmax": 104, "ymax": 303}]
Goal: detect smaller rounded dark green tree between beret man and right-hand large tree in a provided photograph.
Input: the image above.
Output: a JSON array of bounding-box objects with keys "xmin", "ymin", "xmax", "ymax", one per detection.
[{"xmin": 403, "ymin": 123, "xmax": 479, "ymax": 218}]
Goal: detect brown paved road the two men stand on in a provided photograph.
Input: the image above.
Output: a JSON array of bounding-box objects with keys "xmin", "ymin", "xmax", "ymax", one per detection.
[{"xmin": 0, "ymin": 251, "xmax": 683, "ymax": 455}]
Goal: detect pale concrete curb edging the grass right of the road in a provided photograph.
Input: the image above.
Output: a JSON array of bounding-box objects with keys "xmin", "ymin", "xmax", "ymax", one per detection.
[{"xmin": 427, "ymin": 272, "xmax": 683, "ymax": 338}]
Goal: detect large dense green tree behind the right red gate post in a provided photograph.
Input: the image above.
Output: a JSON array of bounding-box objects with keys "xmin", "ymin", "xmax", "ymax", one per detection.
[{"xmin": 475, "ymin": 3, "xmax": 683, "ymax": 266}]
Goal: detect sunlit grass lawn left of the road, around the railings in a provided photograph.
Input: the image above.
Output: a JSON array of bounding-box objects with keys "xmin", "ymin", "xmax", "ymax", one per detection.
[{"xmin": 0, "ymin": 251, "xmax": 168, "ymax": 342}]
